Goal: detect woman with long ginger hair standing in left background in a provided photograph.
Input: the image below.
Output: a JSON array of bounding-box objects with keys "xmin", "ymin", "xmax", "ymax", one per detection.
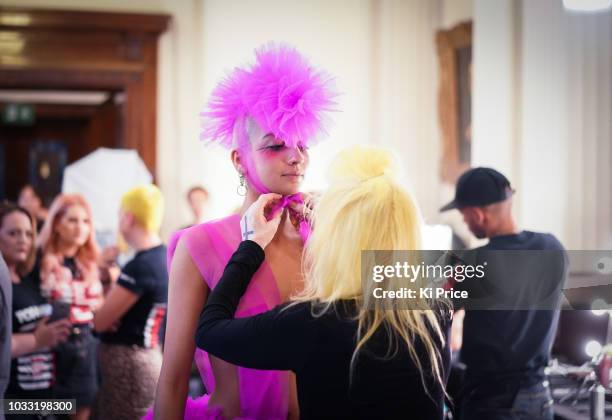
[{"xmin": 40, "ymin": 194, "xmax": 102, "ymax": 419}]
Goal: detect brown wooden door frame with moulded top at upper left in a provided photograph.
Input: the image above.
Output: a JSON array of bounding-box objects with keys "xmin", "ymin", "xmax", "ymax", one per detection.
[{"xmin": 0, "ymin": 7, "xmax": 170, "ymax": 177}]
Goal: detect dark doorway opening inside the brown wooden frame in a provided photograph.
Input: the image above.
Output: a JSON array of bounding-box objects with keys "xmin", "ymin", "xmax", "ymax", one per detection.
[{"xmin": 0, "ymin": 91, "xmax": 122, "ymax": 205}]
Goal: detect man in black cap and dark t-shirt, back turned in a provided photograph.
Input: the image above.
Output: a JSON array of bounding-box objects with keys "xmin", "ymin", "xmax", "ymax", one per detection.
[{"xmin": 440, "ymin": 168, "xmax": 564, "ymax": 420}]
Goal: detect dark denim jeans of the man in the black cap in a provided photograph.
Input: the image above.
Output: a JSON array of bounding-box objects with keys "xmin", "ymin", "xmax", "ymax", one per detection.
[{"xmin": 461, "ymin": 381, "xmax": 553, "ymax": 420}]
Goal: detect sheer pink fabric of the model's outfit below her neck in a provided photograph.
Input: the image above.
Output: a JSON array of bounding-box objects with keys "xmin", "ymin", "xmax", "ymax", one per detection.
[{"xmin": 152, "ymin": 215, "xmax": 289, "ymax": 419}]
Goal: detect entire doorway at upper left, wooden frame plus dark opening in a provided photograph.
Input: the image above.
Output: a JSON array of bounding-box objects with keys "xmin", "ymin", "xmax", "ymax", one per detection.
[{"xmin": 0, "ymin": 7, "xmax": 170, "ymax": 200}]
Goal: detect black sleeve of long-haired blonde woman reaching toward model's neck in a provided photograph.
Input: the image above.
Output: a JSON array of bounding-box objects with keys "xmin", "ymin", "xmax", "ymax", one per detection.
[{"xmin": 196, "ymin": 240, "xmax": 316, "ymax": 371}]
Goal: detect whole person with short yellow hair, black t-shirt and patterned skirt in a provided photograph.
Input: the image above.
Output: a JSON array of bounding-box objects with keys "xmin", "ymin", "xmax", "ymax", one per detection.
[{"xmin": 94, "ymin": 184, "xmax": 168, "ymax": 419}]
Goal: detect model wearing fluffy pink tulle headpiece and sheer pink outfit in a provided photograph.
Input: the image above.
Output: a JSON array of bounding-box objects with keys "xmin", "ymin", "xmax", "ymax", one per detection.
[{"xmin": 150, "ymin": 44, "xmax": 336, "ymax": 419}]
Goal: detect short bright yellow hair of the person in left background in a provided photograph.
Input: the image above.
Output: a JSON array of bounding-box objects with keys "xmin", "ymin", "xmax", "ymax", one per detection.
[{"xmin": 121, "ymin": 184, "xmax": 164, "ymax": 233}]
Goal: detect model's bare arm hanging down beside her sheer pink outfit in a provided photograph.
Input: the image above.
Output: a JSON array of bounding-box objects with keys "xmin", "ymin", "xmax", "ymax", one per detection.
[{"xmin": 155, "ymin": 239, "xmax": 208, "ymax": 420}]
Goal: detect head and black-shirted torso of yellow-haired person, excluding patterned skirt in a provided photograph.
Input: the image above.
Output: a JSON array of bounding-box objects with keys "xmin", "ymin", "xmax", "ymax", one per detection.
[{"xmin": 94, "ymin": 185, "xmax": 168, "ymax": 349}]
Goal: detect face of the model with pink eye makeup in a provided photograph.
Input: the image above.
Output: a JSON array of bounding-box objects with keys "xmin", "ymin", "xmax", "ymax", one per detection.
[{"xmin": 245, "ymin": 134, "xmax": 308, "ymax": 195}]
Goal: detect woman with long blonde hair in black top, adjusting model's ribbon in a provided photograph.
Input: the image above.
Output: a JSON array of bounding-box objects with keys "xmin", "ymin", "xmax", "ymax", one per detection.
[{"xmin": 196, "ymin": 147, "xmax": 450, "ymax": 419}]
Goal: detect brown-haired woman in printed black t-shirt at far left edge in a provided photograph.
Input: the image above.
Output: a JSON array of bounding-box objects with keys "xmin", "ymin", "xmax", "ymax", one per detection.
[{"xmin": 0, "ymin": 204, "xmax": 70, "ymax": 419}]
